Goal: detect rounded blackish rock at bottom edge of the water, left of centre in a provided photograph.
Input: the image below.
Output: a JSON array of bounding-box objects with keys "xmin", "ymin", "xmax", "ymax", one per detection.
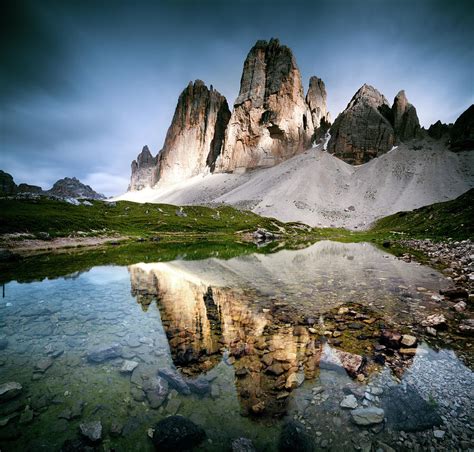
[{"xmin": 152, "ymin": 416, "xmax": 206, "ymax": 452}]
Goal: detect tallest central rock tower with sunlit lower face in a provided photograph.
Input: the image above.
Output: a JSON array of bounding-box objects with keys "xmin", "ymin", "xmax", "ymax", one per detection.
[{"xmin": 216, "ymin": 39, "xmax": 314, "ymax": 172}]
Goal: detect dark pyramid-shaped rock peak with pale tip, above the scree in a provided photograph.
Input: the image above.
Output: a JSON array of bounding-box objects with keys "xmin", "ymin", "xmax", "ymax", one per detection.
[{"xmin": 327, "ymin": 85, "xmax": 395, "ymax": 165}]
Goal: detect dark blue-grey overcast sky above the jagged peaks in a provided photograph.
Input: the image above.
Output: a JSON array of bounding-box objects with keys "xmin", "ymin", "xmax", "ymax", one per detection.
[{"xmin": 0, "ymin": 0, "xmax": 474, "ymax": 195}]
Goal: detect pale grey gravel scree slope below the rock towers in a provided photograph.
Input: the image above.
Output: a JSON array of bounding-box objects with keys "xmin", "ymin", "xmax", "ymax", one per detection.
[{"xmin": 117, "ymin": 139, "xmax": 474, "ymax": 229}]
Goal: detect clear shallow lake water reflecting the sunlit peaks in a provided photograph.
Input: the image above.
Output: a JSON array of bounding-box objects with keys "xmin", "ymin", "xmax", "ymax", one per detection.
[{"xmin": 0, "ymin": 242, "xmax": 474, "ymax": 450}]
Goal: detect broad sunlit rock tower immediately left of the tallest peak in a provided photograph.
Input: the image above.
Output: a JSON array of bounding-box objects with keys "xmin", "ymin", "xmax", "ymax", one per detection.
[{"xmin": 158, "ymin": 80, "xmax": 230, "ymax": 183}]
